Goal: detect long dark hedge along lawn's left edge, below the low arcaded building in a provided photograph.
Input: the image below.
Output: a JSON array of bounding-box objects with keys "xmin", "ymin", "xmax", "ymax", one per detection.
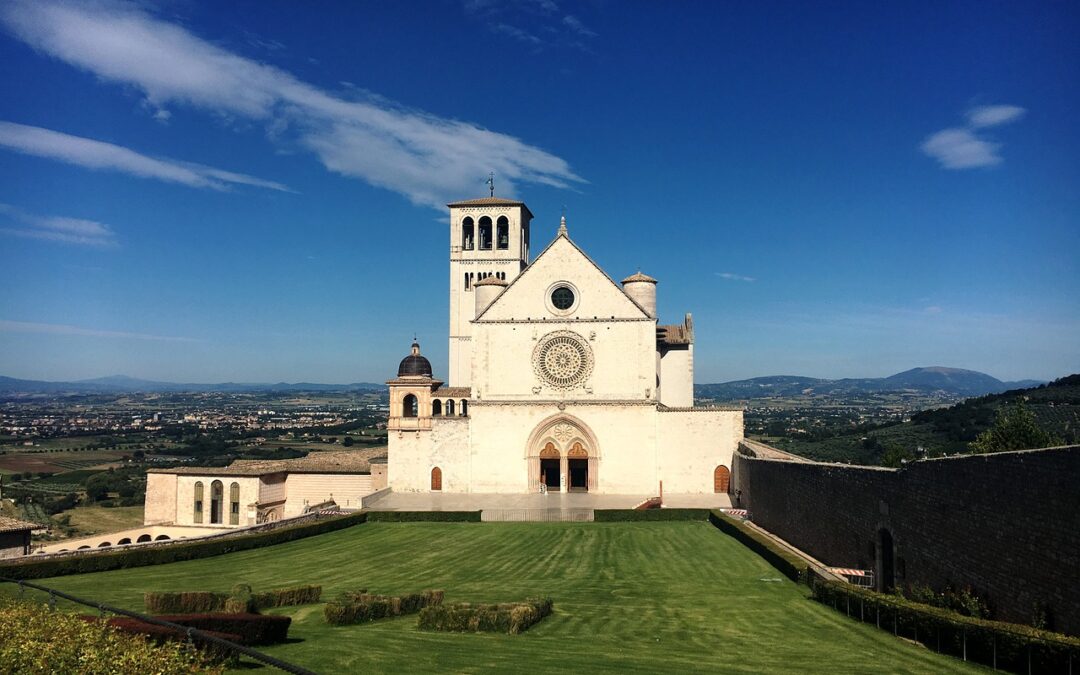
[{"xmin": 0, "ymin": 513, "xmax": 367, "ymax": 579}]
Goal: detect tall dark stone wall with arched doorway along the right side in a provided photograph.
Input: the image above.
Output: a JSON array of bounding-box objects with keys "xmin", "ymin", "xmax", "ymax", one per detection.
[{"xmin": 731, "ymin": 443, "xmax": 1080, "ymax": 634}]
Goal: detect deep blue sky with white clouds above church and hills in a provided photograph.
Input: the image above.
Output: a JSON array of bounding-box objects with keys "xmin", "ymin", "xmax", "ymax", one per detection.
[{"xmin": 0, "ymin": 0, "xmax": 1080, "ymax": 382}]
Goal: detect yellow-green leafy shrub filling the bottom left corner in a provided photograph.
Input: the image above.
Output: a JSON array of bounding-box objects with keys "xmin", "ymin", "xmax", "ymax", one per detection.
[{"xmin": 0, "ymin": 598, "xmax": 220, "ymax": 675}]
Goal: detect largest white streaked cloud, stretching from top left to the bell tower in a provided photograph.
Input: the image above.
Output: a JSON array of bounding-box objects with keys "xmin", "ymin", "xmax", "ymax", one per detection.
[{"xmin": 0, "ymin": 0, "xmax": 583, "ymax": 208}]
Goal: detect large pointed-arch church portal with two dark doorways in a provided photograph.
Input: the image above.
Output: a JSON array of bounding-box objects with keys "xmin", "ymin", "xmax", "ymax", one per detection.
[{"xmin": 525, "ymin": 414, "xmax": 600, "ymax": 492}]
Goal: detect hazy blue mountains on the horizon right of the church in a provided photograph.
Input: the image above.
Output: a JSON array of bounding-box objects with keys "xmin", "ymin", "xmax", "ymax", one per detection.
[{"xmin": 693, "ymin": 366, "xmax": 1041, "ymax": 401}]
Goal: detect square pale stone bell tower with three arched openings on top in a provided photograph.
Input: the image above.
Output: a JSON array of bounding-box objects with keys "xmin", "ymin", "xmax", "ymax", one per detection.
[{"xmin": 447, "ymin": 193, "xmax": 532, "ymax": 387}]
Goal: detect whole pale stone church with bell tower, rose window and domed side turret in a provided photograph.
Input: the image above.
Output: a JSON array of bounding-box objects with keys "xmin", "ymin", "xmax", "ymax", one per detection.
[{"xmin": 388, "ymin": 197, "xmax": 743, "ymax": 495}]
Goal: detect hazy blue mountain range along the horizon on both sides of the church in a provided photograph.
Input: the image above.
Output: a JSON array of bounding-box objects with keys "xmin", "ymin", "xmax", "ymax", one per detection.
[{"xmin": 0, "ymin": 366, "xmax": 1042, "ymax": 401}]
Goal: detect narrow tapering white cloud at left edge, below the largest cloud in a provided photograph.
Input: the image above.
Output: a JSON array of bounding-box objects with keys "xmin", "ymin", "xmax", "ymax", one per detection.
[{"xmin": 0, "ymin": 121, "xmax": 291, "ymax": 192}]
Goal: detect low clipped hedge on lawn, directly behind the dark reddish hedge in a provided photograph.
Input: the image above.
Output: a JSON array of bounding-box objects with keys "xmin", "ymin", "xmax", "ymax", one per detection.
[{"xmin": 150, "ymin": 583, "xmax": 323, "ymax": 613}]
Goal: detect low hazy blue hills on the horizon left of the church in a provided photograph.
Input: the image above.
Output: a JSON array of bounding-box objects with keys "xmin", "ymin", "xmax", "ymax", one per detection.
[{"xmin": 0, "ymin": 375, "xmax": 387, "ymax": 394}]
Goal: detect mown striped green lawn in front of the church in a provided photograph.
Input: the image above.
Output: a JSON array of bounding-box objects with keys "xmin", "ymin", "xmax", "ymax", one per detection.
[{"xmin": 12, "ymin": 523, "xmax": 975, "ymax": 674}]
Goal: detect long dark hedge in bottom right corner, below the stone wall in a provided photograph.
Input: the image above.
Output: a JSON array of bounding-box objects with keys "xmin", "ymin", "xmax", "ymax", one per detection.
[{"xmin": 811, "ymin": 576, "xmax": 1080, "ymax": 673}]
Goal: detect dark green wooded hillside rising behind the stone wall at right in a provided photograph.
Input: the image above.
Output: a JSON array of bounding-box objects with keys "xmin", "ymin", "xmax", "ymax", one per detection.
[{"xmin": 773, "ymin": 374, "xmax": 1080, "ymax": 464}]
